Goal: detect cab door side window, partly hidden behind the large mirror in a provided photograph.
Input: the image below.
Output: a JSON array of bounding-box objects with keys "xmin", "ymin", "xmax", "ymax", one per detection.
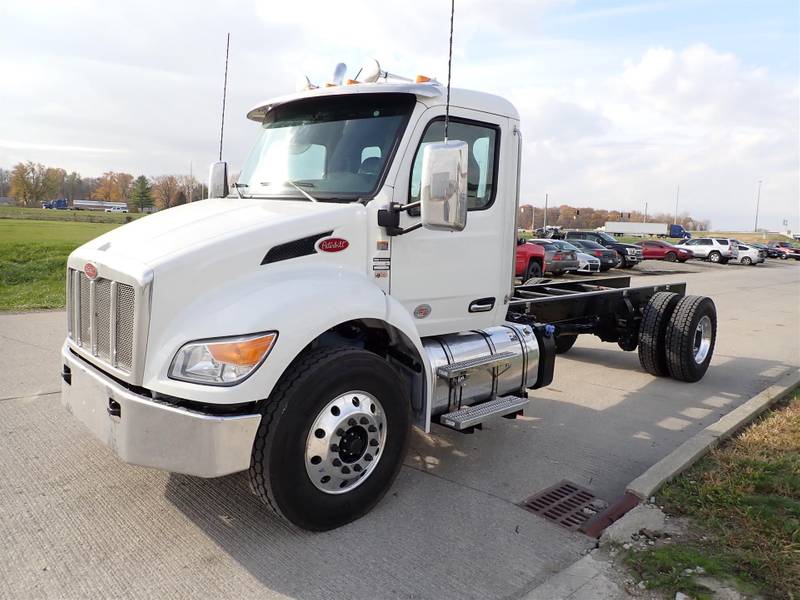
[{"xmin": 408, "ymin": 118, "xmax": 498, "ymax": 210}]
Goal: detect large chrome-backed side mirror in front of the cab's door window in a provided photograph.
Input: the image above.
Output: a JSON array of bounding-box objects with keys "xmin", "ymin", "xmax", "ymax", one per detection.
[{"xmin": 420, "ymin": 141, "xmax": 469, "ymax": 231}]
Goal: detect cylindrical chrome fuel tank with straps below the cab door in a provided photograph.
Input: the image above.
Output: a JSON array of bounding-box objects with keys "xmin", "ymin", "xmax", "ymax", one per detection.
[{"xmin": 422, "ymin": 323, "xmax": 539, "ymax": 416}]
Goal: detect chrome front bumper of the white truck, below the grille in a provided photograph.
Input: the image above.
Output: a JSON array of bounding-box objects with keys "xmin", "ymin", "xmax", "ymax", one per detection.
[{"xmin": 61, "ymin": 345, "xmax": 261, "ymax": 477}]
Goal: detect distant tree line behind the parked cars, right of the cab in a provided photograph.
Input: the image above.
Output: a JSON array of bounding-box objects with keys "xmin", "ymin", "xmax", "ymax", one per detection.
[{"xmin": 517, "ymin": 204, "xmax": 711, "ymax": 231}]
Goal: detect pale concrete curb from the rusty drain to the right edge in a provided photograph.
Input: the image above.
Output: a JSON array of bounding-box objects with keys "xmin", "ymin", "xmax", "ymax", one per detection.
[{"xmin": 625, "ymin": 369, "xmax": 800, "ymax": 500}]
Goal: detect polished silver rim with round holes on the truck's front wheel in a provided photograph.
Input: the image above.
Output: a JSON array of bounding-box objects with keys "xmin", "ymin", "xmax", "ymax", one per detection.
[{"xmin": 305, "ymin": 391, "xmax": 386, "ymax": 494}]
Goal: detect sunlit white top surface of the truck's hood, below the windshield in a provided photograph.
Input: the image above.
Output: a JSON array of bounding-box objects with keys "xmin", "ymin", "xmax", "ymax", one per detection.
[{"xmin": 82, "ymin": 198, "xmax": 356, "ymax": 266}]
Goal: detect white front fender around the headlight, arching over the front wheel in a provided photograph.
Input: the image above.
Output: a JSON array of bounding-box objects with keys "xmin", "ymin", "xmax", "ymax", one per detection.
[{"xmin": 143, "ymin": 264, "xmax": 432, "ymax": 431}]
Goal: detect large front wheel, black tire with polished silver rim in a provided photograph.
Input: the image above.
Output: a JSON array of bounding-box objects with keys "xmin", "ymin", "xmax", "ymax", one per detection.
[{"xmin": 249, "ymin": 347, "xmax": 411, "ymax": 531}]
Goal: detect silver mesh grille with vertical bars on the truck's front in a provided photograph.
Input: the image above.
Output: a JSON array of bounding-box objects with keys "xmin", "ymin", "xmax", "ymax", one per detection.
[{"xmin": 67, "ymin": 269, "xmax": 136, "ymax": 373}]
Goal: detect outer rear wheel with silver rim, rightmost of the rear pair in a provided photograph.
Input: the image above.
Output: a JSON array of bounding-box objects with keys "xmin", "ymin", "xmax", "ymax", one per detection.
[{"xmin": 665, "ymin": 296, "xmax": 717, "ymax": 383}]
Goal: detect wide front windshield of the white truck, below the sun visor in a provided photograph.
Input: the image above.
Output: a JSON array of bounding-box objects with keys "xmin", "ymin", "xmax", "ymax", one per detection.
[{"xmin": 237, "ymin": 93, "xmax": 415, "ymax": 201}]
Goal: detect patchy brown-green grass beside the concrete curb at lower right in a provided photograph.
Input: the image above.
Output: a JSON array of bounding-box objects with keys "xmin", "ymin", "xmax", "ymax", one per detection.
[{"xmin": 626, "ymin": 392, "xmax": 800, "ymax": 599}]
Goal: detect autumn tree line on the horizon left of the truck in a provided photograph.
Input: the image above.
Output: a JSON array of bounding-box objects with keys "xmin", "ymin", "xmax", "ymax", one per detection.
[{"xmin": 0, "ymin": 162, "xmax": 208, "ymax": 212}]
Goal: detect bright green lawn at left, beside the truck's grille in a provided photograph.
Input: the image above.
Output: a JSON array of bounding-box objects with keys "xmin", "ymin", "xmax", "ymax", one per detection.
[{"xmin": 0, "ymin": 218, "xmax": 117, "ymax": 311}]
